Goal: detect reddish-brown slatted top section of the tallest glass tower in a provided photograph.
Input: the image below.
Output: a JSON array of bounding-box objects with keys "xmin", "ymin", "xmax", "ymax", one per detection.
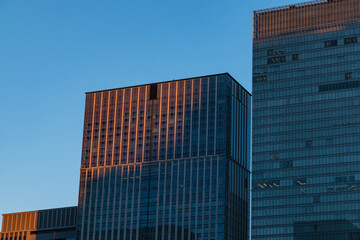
[{"xmin": 253, "ymin": 0, "xmax": 360, "ymax": 40}]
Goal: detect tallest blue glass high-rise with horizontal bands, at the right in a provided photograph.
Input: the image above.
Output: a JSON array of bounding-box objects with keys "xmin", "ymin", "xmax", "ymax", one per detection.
[{"xmin": 252, "ymin": 0, "xmax": 360, "ymax": 240}]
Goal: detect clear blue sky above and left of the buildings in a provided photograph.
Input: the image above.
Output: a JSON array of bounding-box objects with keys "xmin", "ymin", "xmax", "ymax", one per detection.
[{"xmin": 0, "ymin": 0, "xmax": 306, "ymax": 223}]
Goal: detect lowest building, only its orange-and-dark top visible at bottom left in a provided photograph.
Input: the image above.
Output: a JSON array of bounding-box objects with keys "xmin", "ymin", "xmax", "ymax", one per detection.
[{"xmin": 0, "ymin": 207, "xmax": 77, "ymax": 240}]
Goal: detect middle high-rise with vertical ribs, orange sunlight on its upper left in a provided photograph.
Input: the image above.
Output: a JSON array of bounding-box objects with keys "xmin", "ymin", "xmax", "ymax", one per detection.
[{"xmin": 78, "ymin": 73, "xmax": 251, "ymax": 240}]
